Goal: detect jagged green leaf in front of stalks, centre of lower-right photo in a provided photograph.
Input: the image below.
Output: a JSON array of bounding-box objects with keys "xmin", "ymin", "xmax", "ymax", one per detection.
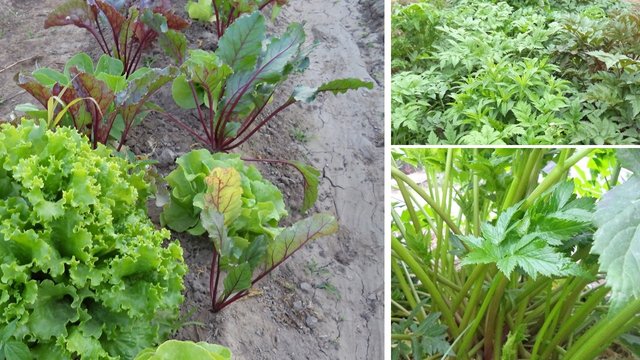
[{"xmin": 460, "ymin": 183, "xmax": 594, "ymax": 279}]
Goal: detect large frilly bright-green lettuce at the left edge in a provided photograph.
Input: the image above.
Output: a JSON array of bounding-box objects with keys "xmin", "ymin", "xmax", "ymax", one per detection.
[{"xmin": 0, "ymin": 121, "xmax": 186, "ymax": 359}]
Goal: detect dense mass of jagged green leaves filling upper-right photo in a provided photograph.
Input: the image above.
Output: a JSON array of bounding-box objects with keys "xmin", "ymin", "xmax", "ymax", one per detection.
[{"xmin": 391, "ymin": 0, "xmax": 640, "ymax": 145}]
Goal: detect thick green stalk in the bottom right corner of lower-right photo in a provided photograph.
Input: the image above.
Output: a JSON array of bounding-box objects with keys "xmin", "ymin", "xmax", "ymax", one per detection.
[{"xmin": 565, "ymin": 299, "xmax": 640, "ymax": 360}]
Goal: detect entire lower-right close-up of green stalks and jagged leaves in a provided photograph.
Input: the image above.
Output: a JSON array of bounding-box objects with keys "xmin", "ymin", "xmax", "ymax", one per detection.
[{"xmin": 391, "ymin": 149, "xmax": 640, "ymax": 360}]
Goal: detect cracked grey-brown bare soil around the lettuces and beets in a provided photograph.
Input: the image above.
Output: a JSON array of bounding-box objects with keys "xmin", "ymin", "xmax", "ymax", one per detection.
[{"xmin": 0, "ymin": 0, "xmax": 384, "ymax": 360}]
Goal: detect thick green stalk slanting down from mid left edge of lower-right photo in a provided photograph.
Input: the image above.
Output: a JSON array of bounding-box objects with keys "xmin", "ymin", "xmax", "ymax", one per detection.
[{"xmin": 391, "ymin": 238, "xmax": 458, "ymax": 337}]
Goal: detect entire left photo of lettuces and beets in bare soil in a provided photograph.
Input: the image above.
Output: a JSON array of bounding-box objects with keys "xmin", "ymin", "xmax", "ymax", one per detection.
[{"xmin": 0, "ymin": 0, "xmax": 384, "ymax": 360}]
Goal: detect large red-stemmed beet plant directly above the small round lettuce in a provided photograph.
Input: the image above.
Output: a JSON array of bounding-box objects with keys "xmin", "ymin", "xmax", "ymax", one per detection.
[{"xmin": 163, "ymin": 11, "xmax": 373, "ymax": 152}]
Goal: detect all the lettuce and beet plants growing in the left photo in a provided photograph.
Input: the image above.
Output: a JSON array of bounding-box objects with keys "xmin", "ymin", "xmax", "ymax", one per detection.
[{"xmin": 0, "ymin": 0, "xmax": 372, "ymax": 360}]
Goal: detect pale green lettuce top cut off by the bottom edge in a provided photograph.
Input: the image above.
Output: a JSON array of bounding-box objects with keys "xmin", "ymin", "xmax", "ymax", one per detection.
[{"xmin": 134, "ymin": 340, "xmax": 231, "ymax": 360}]
